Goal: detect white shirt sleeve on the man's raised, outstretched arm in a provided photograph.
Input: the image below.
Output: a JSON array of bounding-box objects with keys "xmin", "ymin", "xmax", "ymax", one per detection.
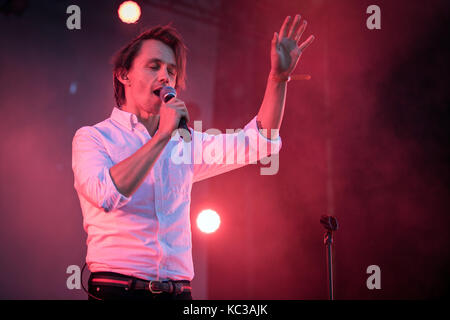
[{"xmin": 193, "ymin": 116, "xmax": 281, "ymax": 182}]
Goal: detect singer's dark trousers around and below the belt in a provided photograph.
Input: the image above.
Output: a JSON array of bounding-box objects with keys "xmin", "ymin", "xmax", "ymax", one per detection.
[{"xmin": 88, "ymin": 272, "xmax": 192, "ymax": 301}]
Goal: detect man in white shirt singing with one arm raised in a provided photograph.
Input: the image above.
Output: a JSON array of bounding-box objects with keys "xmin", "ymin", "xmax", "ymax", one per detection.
[{"xmin": 72, "ymin": 15, "xmax": 314, "ymax": 300}]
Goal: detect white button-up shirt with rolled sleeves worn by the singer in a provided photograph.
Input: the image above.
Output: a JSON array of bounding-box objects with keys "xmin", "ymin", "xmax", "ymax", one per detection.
[{"xmin": 72, "ymin": 108, "xmax": 281, "ymax": 280}]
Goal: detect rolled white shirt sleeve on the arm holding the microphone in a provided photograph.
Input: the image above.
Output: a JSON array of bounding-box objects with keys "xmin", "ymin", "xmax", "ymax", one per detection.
[{"xmin": 72, "ymin": 127, "xmax": 132, "ymax": 212}]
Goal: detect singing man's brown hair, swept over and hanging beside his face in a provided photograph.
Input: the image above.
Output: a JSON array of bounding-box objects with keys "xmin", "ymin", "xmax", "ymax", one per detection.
[{"xmin": 113, "ymin": 24, "xmax": 187, "ymax": 108}]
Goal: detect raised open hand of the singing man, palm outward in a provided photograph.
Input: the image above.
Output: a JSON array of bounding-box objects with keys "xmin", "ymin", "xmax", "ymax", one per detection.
[{"xmin": 270, "ymin": 14, "xmax": 314, "ymax": 79}]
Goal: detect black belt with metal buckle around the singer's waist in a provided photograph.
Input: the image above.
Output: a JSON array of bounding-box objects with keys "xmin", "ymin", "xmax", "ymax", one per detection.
[{"xmin": 89, "ymin": 273, "xmax": 192, "ymax": 294}]
